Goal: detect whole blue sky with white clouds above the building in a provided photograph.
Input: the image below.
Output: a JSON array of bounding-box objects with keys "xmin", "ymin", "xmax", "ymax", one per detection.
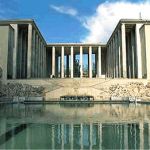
[{"xmin": 0, "ymin": 0, "xmax": 150, "ymax": 43}]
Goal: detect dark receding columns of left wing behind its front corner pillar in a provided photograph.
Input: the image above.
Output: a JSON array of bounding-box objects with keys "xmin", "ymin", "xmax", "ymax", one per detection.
[{"xmin": 28, "ymin": 25, "xmax": 46, "ymax": 78}]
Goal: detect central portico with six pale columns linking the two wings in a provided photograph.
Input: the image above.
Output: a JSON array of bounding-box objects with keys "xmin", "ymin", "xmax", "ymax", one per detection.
[{"xmin": 47, "ymin": 43, "xmax": 106, "ymax": 78}]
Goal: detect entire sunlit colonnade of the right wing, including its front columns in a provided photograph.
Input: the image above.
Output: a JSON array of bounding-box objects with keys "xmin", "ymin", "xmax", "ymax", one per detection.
[{"xmin": 106, "ymin": 23, "xmax": 142, "ymax": 78}]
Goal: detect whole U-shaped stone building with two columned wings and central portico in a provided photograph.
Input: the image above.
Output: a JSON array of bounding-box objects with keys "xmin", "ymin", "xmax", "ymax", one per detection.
[{"xmin": 0, "ymin": 19, "xmax": 150, "ymax": 80}]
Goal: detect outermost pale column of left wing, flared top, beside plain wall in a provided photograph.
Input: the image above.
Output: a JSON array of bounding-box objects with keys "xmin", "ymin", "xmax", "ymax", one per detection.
[{"xmin": 12, "ymin": 24, "xmax": 18, "ymax": 79}]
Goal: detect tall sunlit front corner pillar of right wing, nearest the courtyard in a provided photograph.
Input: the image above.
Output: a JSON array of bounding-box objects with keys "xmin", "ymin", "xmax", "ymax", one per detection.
[{"xmin": 121, "ymin": 23, "xmax": 127, "ymax": 78}]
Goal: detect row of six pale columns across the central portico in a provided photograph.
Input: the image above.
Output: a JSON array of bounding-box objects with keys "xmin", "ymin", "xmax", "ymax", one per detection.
[{"xmin": 52, "ymin": 45, "xmax": 102, "ymax": 78}]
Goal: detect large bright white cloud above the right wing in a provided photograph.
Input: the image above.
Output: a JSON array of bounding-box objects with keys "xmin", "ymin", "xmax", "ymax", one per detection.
[{"xmin": 81, "ymin": 1, "xmax": 150, "ymax": 43}]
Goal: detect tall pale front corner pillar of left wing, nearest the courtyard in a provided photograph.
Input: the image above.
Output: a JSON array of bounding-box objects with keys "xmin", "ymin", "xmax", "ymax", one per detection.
[{"xmin": 27, "ymin": 24, "xmax": 32, "ymax": 78}]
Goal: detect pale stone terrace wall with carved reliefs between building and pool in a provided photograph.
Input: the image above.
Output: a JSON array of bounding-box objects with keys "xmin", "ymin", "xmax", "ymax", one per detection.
[{"xmin": 4, "ymin": 78, "xmax": 150, "ymax": 100}]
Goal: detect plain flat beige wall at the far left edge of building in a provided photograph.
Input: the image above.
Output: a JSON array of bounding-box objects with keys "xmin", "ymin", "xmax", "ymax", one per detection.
[{"xmin": 0, "ymin": 26, "xmax": 10, "ymax": 81}]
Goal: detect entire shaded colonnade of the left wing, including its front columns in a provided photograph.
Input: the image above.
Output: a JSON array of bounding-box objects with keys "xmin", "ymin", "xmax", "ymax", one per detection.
[{"xmin": 12, "ymin": 23, "xmax": 46, "ymax": 79}]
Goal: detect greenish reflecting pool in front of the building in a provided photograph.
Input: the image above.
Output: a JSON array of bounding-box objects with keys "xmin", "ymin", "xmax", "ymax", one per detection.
[{"xmin": 0, "ymin": 104, "xmax": 150, "ymax": 149}]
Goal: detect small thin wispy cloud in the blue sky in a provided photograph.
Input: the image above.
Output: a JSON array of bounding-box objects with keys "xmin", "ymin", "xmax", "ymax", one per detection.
[{"xmin": 50, "ymin": 5, "xmax": 78, "ymax": 16}]
